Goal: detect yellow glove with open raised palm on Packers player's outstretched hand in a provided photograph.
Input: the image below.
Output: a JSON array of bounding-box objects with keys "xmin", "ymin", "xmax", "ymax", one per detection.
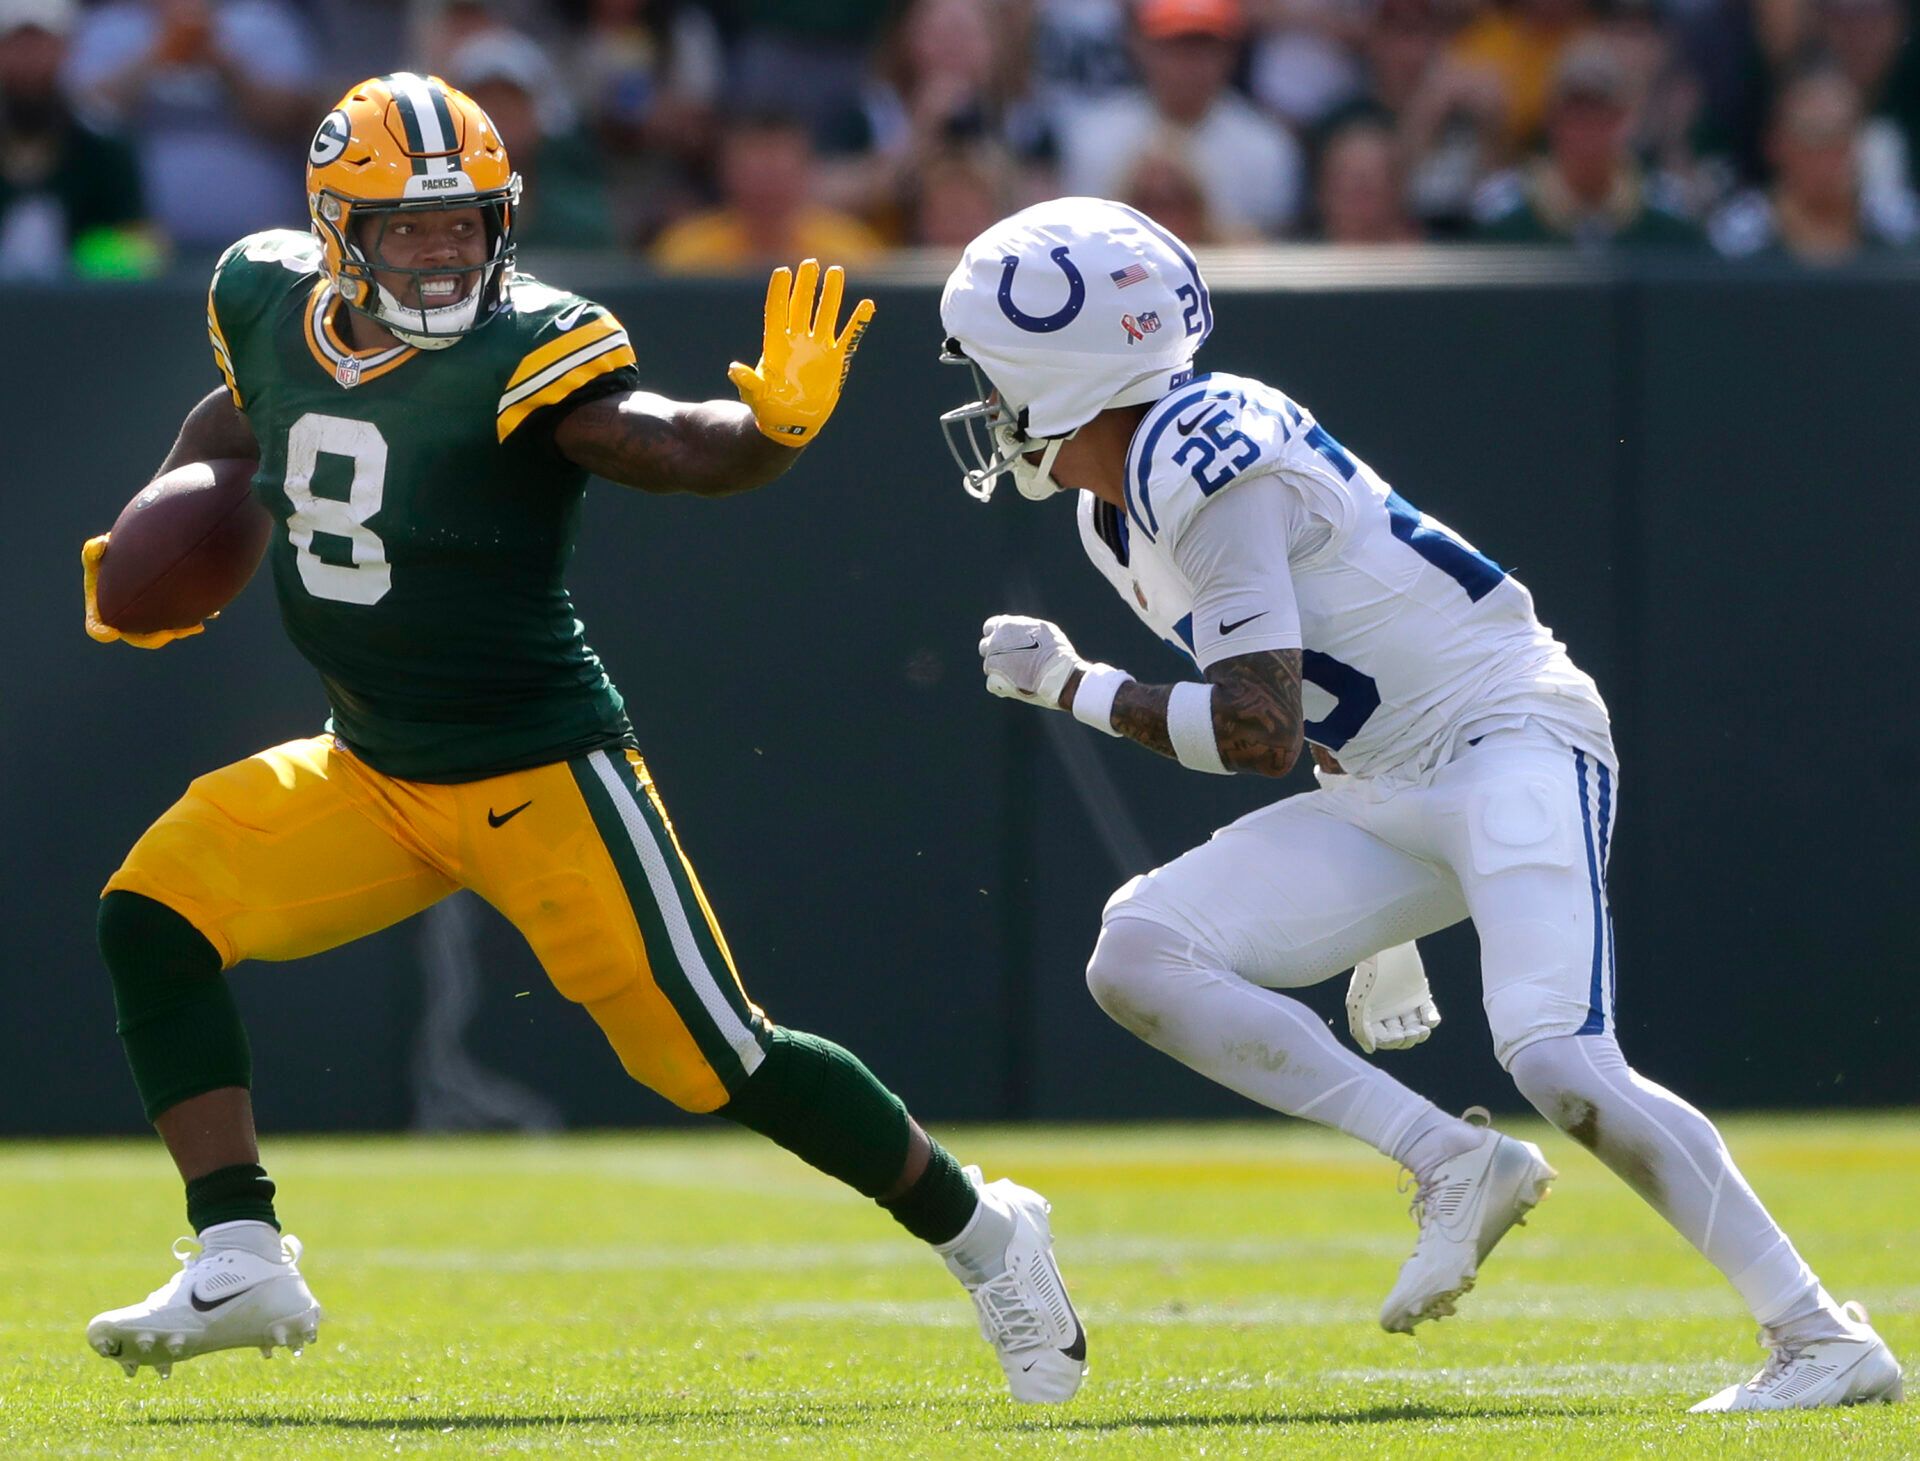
[{"xmin": 726, "ymin": 259, "xmax": 874, "ymax": 447}]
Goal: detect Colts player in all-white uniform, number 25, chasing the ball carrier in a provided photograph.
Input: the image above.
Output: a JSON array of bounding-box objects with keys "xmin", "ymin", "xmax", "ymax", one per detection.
[{"xmin": 941, "ymin": 198, "xmax": 1901, "ymax": 1411}]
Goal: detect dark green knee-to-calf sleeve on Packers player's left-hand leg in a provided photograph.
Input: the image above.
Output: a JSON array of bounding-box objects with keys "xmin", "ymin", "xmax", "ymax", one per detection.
[{"xmin": 100, "ymin": 891, "xmax": 253, "ymax": 1121}]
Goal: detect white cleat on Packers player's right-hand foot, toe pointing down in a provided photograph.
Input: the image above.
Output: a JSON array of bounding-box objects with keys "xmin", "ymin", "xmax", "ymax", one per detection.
[{"xmin": 947, "ymin": 1167, "xmax": 1087, "ymax": 1405}]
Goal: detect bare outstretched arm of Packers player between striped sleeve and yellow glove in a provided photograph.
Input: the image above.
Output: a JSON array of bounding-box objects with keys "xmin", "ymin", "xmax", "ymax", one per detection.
[{"xmin": 553, "ymin": 390, "xmax": 801, "ymax": 497}]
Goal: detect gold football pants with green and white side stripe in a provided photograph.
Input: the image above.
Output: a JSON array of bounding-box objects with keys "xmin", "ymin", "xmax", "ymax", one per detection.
[{"xmin": 108, "ymin": 735, "xmax": 770, "ymax": 1112}]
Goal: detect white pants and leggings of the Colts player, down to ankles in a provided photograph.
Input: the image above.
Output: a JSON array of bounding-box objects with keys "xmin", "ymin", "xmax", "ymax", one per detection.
[{"xmin": 1087, "ymin": 730, "xmax": 1832, "ymax": 1327}]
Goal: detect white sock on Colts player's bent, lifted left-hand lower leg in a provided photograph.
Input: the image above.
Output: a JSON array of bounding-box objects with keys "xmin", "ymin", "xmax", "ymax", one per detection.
[{"xmin": 1087, "ymin": 918, "xmax": 1480, "ymax": 1160}]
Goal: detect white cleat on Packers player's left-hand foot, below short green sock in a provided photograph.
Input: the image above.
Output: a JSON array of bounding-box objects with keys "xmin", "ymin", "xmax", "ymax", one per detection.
[{"xmin": 86, "ymin": 1236, "xmax": 321, "ymax": 1380}]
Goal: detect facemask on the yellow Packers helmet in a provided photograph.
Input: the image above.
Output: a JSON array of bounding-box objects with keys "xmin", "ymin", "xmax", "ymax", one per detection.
[{"xmin": 315, "ymin": 175, "xmax": 520, "ymax": 349}]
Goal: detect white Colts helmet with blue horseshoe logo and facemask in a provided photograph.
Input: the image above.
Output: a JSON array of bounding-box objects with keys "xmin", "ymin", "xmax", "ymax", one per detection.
[{"xmin": 941, "ymin": 198, "xmax": 1213, "ymax": 501}]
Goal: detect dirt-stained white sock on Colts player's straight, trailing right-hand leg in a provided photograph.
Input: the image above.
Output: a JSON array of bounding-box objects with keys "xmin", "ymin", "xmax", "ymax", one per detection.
[{"xmin": 1509, "ymin": 1035, "xmax": 1839, "ymax": 1338}]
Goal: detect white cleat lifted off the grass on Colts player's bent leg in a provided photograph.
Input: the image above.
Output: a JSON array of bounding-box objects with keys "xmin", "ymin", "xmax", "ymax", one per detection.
[{"xmin": 1380, "ymin": 1106, "xmax": 1559, "ymax": 1334}]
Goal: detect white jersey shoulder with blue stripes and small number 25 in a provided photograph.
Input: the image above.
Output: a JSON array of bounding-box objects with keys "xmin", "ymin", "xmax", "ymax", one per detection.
[{"xmin": 1125, "ymin": 374, "xmax": 1290, "ymax": 545}]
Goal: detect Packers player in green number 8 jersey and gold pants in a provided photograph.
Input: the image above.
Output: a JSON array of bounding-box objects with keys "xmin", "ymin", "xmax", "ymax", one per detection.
[{"xmin": 83, "ymin": 73, "xmax": 1087, "ymax": 1401}]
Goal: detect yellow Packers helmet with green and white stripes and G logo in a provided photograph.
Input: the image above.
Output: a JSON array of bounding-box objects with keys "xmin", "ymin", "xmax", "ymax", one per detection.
[{"xmin": 307, "ymin": 71, "xmax": 520, "ymax": 349}]
